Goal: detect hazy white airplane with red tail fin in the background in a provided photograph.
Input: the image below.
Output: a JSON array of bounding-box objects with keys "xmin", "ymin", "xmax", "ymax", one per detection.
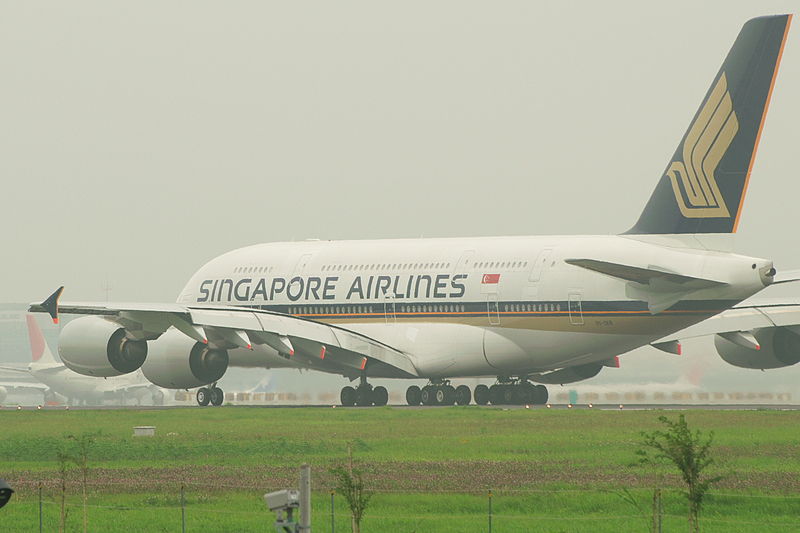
[{"xmin": 3, "ymin": 315, "xmax": 164, "ymax": 405}]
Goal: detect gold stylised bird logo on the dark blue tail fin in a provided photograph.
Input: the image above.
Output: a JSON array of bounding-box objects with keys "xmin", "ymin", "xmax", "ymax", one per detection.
[{"xmin": 667, "ymin": 73, "xmax": 739, "ymax": 218}]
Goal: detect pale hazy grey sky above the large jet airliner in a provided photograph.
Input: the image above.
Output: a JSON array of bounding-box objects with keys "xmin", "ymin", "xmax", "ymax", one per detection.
[{"xmin": 0, "ymin": 0, "xmax": 800, "ymax": 302}]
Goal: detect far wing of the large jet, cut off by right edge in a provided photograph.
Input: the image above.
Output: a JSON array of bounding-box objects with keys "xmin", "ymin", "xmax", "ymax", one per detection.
[{"xmin": 653, "ymin": 302, "xmax": 800, "ymax": 345}]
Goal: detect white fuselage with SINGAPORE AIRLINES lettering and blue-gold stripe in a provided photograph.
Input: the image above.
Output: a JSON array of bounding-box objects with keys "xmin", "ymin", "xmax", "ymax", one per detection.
[{"xmin": 178, "ymin": 236, "xmax": 772, "ymax": 377}]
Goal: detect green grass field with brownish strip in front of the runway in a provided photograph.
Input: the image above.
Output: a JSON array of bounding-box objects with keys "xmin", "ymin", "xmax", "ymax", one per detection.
[{"xmin": 0, "ymin": 407, "xmax": 800, "ymax": 533}]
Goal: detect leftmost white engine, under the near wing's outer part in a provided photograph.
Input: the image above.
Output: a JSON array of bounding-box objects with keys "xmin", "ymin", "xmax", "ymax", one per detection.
[{"xmin": 58, "ymin": 316, "xmax": 147, "ymax": 377}]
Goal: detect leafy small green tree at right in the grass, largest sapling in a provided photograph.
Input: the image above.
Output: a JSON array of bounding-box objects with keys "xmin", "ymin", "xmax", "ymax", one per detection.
[{"xmin": 636, "ymin": 415, "xmax": 722, "ymax": 532}]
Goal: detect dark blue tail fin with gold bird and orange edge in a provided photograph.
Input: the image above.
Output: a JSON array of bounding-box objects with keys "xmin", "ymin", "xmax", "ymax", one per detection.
[{"xmin": 626, "ymin": 15, "xmax": 792, "ymax": 234}]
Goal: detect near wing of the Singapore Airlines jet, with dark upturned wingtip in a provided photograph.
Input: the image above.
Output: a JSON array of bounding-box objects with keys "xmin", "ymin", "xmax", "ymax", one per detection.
[{"xmin": 29, "ymin": 287, "xmax": 418, "ymax": 377}]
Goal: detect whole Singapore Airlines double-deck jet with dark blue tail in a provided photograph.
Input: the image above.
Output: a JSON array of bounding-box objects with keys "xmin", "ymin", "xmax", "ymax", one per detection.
[{"xmin": 31, "ymin": 15, "xmax": 800, "ymax": 405}]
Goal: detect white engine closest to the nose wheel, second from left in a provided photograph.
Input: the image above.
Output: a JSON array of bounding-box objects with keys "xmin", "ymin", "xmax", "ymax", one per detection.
[{"xmin": 142, "ymin": 328, "xmax": 228, "ymax": 389}]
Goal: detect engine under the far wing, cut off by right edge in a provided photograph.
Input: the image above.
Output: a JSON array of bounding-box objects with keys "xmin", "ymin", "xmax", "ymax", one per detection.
[{"xmin": 714, "ymin": 327, "xmax": 800, "ymax": 370}]
